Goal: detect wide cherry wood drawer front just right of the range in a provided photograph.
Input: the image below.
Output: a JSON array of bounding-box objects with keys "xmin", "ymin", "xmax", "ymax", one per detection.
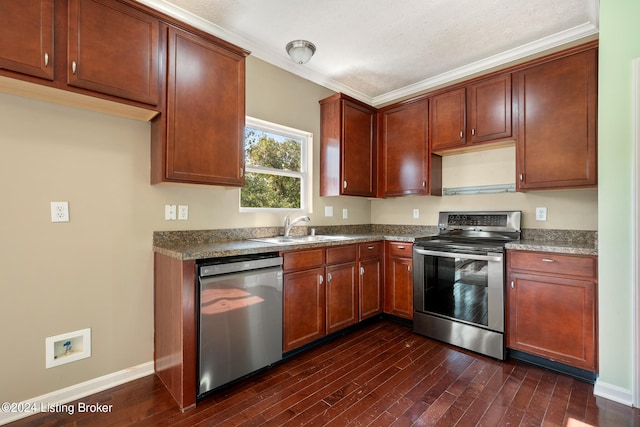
[{"xmin": 509, "ymin": 251, "xmax": 596, "ymax": 278}]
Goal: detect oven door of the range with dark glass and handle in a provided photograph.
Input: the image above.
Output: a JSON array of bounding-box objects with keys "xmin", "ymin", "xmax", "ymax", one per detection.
[{"xmin": 414, "ymin": 247, "xmax": 504, "ymax": 332}]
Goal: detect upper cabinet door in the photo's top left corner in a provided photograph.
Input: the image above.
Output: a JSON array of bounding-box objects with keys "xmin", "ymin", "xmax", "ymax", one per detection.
[{"xmin": 0, "ymin": 0, "xmax": 54, "ymax": 80}]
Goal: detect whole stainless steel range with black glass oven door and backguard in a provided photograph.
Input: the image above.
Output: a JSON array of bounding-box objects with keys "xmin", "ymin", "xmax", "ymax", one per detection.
[{"xmin": 413, "ymin": 211, "xmax": 521, "ymax": 360}]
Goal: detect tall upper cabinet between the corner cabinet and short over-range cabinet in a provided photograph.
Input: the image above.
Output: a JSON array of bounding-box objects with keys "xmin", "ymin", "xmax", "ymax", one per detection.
[{"xmin": 379, "ymin": 99, "xmax": 442, "ymax": 197}]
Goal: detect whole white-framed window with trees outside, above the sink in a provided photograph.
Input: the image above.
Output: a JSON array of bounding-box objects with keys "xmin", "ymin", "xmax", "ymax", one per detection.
[{"xmin": 240, "ymin": 117, "xmax": 313, "ymax": 212}]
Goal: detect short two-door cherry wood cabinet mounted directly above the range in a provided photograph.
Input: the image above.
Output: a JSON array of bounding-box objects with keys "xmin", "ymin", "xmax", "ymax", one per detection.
[{"xmin": 429, "ymin": 73, "xmax": 513, "ymax": 152}]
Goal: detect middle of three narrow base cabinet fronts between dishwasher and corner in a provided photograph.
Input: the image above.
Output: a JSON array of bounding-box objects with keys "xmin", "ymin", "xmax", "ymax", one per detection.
[{"xmin": 326, "ymin": 245, "xmax": 359, "ymax": 334}]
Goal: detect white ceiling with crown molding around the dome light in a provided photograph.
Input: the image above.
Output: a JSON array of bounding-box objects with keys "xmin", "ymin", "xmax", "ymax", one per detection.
[{"xmin": 138, "ymin": 0, "xmax": 599, "ymax": 106}]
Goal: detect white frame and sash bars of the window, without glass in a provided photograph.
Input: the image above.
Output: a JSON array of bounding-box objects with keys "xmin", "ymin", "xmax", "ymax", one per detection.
[{"xmin": 238, "ymin": 116, "xmax": 313, "ymax": 213}]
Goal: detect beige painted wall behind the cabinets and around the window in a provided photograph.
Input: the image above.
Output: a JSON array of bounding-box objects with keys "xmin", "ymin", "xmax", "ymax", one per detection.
[{"xmin": 0, "ymin": 53, "xmax": 596, "ymax": 401}]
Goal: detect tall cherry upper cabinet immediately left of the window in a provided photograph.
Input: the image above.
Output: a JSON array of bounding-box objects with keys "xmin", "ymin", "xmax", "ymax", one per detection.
[{"xmin": 151, "ymin": 27, "xmax": 247, "ymax": 187}]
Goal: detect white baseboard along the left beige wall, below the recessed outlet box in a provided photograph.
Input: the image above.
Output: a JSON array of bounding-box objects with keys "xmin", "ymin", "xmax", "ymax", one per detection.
[{"xmin": 0, "ymin": 361, "xmax": 154, "ymax": 425}]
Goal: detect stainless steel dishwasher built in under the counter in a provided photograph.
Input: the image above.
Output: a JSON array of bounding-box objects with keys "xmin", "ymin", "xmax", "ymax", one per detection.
[{"xmin": 198, "ymin": 253, "xmax": 282, "ymax": 396}]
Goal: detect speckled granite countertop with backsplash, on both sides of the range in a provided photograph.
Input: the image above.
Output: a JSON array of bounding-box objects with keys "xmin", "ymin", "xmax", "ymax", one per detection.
[{"xmin": 153, "ymin": 225, "xmax": 598, "ymax": 261}]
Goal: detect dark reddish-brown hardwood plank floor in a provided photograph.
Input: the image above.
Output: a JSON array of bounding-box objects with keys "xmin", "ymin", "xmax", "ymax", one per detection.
[{"xmin": 9, "ymin": 320, "xmax": 640, "ymax": 427}]
